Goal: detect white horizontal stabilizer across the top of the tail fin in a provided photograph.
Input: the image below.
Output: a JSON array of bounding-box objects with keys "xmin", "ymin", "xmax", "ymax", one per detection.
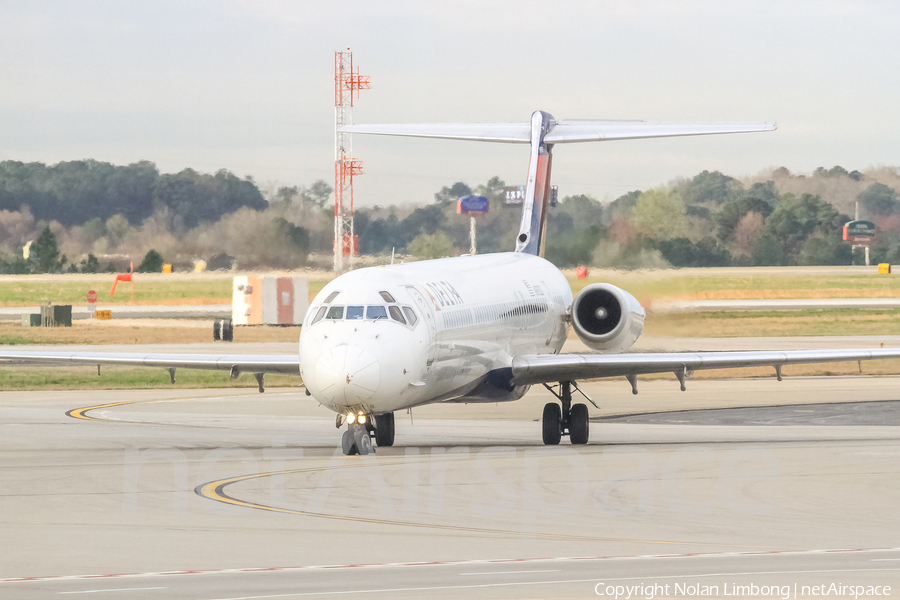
[{"xmin": 341, "ymin": 120, "xmax": 777, "ymax": 144}]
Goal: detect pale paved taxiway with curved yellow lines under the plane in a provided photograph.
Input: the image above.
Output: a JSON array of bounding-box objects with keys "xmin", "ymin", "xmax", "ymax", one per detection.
[{"xmin": 0, "ymin": 377, "xmax": 900, "ymax": 600}]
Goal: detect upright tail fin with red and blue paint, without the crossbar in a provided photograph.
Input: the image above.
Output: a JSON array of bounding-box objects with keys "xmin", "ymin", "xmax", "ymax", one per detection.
[{"xmin": 516, "ymin": 110, "xmax": 556, "ymax": 256}]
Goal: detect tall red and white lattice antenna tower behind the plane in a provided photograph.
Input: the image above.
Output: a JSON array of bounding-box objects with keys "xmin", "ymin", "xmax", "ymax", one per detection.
[{"xmin": 334, "ymin": 46, "xmax": 369, "ymax": 274}]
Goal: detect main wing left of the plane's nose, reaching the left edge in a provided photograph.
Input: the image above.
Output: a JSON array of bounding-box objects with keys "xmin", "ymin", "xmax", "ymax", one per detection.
[{"xmin": 0, "ymin": 350, "xmax": 300, "ymax": 376}]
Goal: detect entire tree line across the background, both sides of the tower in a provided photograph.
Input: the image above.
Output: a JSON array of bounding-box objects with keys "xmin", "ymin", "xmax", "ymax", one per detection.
[{"xmin": 0, "ymin": 160, "xmax": 900, "ymax": 273}]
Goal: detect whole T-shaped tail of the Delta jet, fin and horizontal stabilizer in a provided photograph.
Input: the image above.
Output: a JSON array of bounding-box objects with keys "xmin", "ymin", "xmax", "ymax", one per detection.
[{"xmin": 341, "ymin": 110, "xmax": 777, "ymax": 256}]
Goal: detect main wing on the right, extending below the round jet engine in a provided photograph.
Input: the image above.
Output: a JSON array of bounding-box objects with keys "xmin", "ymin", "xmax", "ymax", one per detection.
[{"xmin": 512, "ymin": 348, "xmax": 900, "ymax": 393}]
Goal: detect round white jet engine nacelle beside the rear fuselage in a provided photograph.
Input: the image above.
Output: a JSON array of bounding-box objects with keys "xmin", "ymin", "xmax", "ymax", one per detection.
[{"xmin": 572, "ymin": 283, "xmax": 646, "ymax": 354}]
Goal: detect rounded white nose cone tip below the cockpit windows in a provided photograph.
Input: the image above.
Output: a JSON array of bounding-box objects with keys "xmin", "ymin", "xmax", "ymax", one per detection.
[{"xmin": 316, "ymin": 345, "xmax": 381, "ymax": 406}]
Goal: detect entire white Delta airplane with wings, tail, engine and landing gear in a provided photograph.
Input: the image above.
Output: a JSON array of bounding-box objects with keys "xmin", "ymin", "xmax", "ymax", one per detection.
[{"xmin": 7, "ymin": 111, "xmax": 900, "ymax": 454}]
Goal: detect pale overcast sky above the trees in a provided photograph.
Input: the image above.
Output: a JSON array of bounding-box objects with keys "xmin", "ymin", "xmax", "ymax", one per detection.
[{"xmin": 0, "ymin": 0, "xmax": 900, "ymax": 205}]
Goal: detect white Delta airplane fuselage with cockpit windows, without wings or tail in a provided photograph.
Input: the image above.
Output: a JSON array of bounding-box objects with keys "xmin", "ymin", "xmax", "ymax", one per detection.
[{"xmin": 300, "ymin": 253, "xmax": 572, "ymax": 414}]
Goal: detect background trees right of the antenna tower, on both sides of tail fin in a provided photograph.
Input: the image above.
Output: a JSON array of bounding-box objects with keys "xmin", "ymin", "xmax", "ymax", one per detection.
[{"xmin": 357, "ymin": 166, "xmax": 900, "ymax": 268}]
